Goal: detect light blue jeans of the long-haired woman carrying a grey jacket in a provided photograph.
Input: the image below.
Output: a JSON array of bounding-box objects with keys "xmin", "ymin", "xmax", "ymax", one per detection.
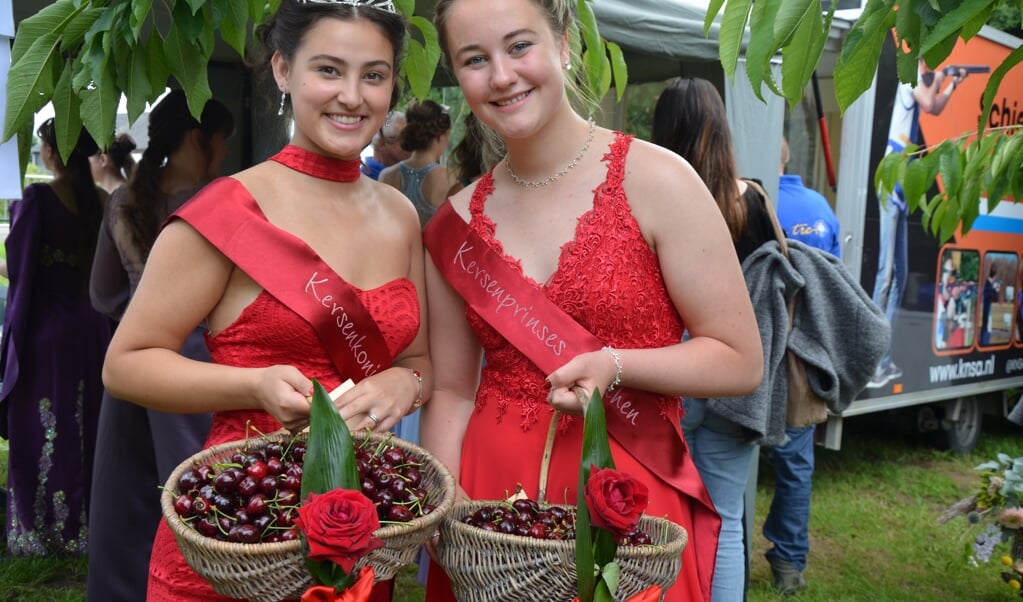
[{"xmin": 682, "ymin": 399, "xmax": 757, "ymax": 602}]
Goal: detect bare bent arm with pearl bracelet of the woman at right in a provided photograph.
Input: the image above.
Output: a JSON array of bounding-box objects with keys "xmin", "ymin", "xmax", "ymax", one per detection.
[{"xmin": 549, "ymin": 140, "xmax": 763, "ymax": 412}]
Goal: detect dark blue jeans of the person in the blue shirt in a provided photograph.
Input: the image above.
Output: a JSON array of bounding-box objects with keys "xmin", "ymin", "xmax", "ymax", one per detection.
[{"xmin": 763, "ymin": 426, "xmax": 814, "ymax": 570}]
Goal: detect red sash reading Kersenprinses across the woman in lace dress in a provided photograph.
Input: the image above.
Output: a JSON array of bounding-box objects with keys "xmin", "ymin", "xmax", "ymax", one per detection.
[{"xmin": 424, "ymin": 203, "xmax": 721, "ymax": 598}]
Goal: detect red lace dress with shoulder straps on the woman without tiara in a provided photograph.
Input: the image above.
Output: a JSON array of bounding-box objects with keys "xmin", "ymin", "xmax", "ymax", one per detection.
[{"xmin": 427, "ymin": 134, "xmax": 704, "ymax": 602}]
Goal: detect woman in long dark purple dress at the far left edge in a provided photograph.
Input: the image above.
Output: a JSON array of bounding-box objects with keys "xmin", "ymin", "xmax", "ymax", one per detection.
[{"xmin": 0, "ymin": 119, "xmax": 110, "ymax": 556}]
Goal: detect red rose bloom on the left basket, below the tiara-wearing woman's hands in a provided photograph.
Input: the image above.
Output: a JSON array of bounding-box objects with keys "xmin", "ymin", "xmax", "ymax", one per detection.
[{"xmin": 295, "ymin": 489, "xmax": 384, "ymax": 573}]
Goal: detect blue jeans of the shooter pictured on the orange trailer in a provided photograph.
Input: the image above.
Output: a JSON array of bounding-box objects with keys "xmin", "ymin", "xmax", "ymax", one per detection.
[{"xmin": 873, "ymin": 192, "xmax": 909, "ymax": 366}]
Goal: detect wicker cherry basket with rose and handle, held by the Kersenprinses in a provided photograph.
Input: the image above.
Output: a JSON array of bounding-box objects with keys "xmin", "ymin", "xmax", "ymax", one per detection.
[{"xmin": 438, "ymin": 391, "xmax": 687, "ymax": 602}]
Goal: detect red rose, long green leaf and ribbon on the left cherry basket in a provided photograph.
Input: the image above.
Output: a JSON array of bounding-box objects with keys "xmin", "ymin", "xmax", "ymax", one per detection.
[{"xmin": 295, "ymin": 380, "xmax": 384, "ymax": 602}]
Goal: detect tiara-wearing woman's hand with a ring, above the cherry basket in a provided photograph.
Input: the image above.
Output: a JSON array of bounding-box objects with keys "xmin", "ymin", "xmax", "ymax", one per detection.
[{"xmin": 335, "ymin": 367, "xmax": 420, "ymax": 432}]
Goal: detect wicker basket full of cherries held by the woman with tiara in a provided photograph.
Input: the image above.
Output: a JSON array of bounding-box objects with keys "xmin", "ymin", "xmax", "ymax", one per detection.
[{"xmin": 161, "ymin": 384, "xmax": 455, "ymax": 602}]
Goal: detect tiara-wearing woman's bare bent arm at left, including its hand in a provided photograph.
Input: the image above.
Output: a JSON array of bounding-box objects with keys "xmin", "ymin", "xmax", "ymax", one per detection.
[{"xmin": 103, "ymin": 220, "xmax": 311, "ymax": 430}]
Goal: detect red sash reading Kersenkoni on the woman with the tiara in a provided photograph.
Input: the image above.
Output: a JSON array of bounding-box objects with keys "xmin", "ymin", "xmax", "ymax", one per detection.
[{"xmin": 174, "ymin": 177, "xmax": 391, "ymax": 382}]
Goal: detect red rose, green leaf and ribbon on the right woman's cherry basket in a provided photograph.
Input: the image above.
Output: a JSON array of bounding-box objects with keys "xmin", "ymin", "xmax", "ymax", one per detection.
[{"xmin": 575, "ymin": 390, "xmax": 661, "ymax": 602}]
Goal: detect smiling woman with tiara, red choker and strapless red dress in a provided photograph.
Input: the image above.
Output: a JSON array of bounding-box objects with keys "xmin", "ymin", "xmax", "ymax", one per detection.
[{"xmin": 103, "ymin": 0, "xmax": 432, "ymax": 601}]
